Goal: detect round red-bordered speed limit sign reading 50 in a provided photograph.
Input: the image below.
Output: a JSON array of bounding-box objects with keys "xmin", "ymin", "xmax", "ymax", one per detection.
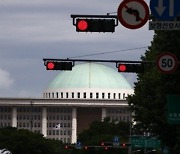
[{"xmin": 156, "ymin": 52, "xmax": 178, "ymax": 73}]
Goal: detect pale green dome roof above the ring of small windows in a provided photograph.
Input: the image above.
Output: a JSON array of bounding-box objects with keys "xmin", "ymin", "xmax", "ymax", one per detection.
[{"xmin": 48, "ymin": 63, "xmax": 132, "ymax": 89}]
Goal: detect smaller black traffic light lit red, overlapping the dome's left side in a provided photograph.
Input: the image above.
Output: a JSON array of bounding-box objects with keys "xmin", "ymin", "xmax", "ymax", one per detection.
[{"xmin": 45, "ymin": 61, "xmax": 73, "ymax": 71}]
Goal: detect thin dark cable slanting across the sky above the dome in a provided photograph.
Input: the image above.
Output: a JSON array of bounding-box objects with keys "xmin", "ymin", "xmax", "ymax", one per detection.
[{"xmin": 69, "ymin": 46, "xmax": 147, "ymax": 58}]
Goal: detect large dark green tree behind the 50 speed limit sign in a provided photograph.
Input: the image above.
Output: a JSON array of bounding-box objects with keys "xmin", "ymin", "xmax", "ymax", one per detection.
[{"xmin": 128, "ymin": 31, "xmax": 180, "ymax": 154}]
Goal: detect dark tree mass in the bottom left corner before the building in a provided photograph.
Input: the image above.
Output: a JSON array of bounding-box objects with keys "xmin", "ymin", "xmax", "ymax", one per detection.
[{"xmin": 0, "ymin": 127, "xmax": 66, "ymax": 154}]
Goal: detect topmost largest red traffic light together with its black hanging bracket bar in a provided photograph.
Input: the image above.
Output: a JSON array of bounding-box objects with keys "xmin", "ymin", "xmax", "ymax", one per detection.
[{"xmin": 71, "ymin": 15, "xmax": 118, "ymax": 33}]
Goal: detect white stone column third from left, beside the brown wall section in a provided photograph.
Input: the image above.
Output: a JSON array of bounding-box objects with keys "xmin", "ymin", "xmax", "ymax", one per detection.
[{"xmin": 71, "ymin": 107, "xmax": 77, "ymax": 143}]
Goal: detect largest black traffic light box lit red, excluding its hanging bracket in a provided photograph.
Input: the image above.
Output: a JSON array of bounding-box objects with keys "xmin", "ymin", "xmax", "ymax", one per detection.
[{"xmin": 76, "ymin": 18, "xmax": 115, "ymax": 32}]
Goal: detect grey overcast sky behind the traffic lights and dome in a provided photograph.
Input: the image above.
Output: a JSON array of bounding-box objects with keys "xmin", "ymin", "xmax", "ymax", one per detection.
[{"xmin": 0, "ymin": 0, "xmax": 154, "ymax": 97}]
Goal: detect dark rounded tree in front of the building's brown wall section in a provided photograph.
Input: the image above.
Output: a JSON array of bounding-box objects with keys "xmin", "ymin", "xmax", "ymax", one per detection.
[{"xmin": 78, "ymin": 118, "xmax": 129, "ymax": 145}]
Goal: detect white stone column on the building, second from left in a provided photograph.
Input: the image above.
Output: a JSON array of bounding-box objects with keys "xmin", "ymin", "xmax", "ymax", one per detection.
[{"xmin": 42, "ymin": 107, "xmax": 47, "ymax": 137}]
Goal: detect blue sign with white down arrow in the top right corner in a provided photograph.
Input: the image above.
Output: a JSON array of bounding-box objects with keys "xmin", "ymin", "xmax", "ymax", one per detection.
[{"xmin": 150, "ymin": 0, "xmax": 180, "ymax": 21}]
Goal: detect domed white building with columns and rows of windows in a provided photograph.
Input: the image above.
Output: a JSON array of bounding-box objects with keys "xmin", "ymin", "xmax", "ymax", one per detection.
[{"xmin": 0, "ymin": 63, "xmax": 133, "ymax": 143}]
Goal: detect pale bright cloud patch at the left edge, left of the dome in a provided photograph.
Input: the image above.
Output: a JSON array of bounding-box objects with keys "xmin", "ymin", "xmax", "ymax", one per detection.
[{"xmin": 0, "ymin": 68, "xmax": 14, "ymax": 89}]
